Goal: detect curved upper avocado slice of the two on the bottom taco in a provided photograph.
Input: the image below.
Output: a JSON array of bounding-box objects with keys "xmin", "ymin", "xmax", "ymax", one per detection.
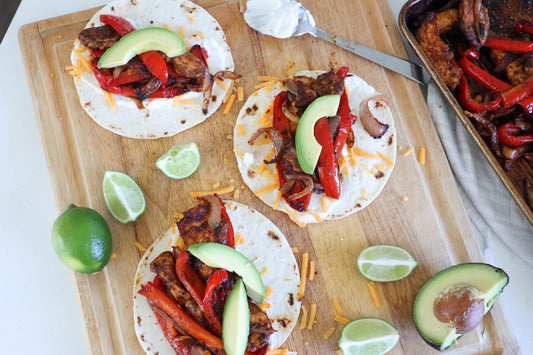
[{"xmin": 189, "ymin": 243, "xmax": 265, "ymax": 304}]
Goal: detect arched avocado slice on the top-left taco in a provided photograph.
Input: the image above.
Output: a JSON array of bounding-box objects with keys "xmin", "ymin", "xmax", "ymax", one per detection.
[{"xmin": 98, "ymin": 27, "xmax": 186, "ymax": 68}]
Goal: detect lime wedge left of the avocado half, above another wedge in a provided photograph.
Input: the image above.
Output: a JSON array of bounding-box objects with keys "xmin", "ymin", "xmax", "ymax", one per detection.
[{"xmin": 357, "ymin": 245, "xmax": 418, "ymax": 282}]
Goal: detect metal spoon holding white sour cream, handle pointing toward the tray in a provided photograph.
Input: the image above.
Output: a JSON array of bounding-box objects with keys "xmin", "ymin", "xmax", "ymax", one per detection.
[{"xmin": 244, "ymin": 0, "xmax": 430, "ymax": 84}]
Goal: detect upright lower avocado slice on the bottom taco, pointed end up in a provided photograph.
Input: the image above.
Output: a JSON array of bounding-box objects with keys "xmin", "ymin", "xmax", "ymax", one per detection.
[{"xmin": 222, "ymin": 280, "xmax": 250, "ymax": 355}]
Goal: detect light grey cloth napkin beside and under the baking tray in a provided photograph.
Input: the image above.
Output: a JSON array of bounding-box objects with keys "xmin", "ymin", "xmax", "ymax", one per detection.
[{"xmin": 427, "ymin": 82, "xmax": 533, "ymax": 265}]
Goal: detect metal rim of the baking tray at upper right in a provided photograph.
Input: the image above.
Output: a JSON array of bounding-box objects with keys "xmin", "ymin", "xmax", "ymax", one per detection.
[{"xmin": 398, "ymin": 0, "xmax": 533, "ymax": 224}]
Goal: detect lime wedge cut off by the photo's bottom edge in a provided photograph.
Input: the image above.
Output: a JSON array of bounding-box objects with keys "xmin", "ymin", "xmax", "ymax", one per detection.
[{"xmin": 339, "ymin": 318, "xmax": 400, "ymax": 355}]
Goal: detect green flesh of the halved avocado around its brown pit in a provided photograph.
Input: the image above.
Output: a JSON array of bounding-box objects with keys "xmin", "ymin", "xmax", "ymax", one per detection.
[{"xmin": 413, "ymin": 263, "xmax": 509, "ymax": 350}]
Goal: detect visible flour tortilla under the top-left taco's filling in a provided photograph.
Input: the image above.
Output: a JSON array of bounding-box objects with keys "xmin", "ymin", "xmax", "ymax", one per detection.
[{"xmin": 71, "ymin": 0, "xmax": 234, "ymax": 138}]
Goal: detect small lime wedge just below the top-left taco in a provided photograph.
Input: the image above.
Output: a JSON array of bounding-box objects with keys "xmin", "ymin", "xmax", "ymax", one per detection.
[{"xmin": 155, "ymin": 142, "xmax": 200, "ymax": 179}]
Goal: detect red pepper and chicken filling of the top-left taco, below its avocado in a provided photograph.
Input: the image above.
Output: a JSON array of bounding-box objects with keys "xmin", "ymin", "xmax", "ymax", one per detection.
[{"xmin": 78, "ymin": 14, "xmax": 240, "ymax": 114}]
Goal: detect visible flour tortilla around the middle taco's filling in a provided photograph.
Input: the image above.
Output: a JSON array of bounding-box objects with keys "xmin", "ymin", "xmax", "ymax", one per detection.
[{"xmin": 233, "ymin": 70, "xmax": 396, "ymax": 224}]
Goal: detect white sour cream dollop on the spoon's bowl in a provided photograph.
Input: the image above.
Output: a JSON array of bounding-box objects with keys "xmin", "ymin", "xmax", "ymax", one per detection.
[{"xmin": 244, "ymin": 0, "xmax": 314, "ymax": 38}]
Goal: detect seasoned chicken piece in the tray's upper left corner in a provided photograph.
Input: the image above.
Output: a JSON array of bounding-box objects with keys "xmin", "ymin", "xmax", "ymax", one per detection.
[{"xmin": 417, "ymin": 9, "xmax": 463, "ymax": 90}]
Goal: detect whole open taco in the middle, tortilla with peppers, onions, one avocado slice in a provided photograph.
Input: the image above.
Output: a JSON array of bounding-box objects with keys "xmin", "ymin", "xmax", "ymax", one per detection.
[{"xmin": 234, "ymin": 67, "xmax": 396, "ymax": 224}]
